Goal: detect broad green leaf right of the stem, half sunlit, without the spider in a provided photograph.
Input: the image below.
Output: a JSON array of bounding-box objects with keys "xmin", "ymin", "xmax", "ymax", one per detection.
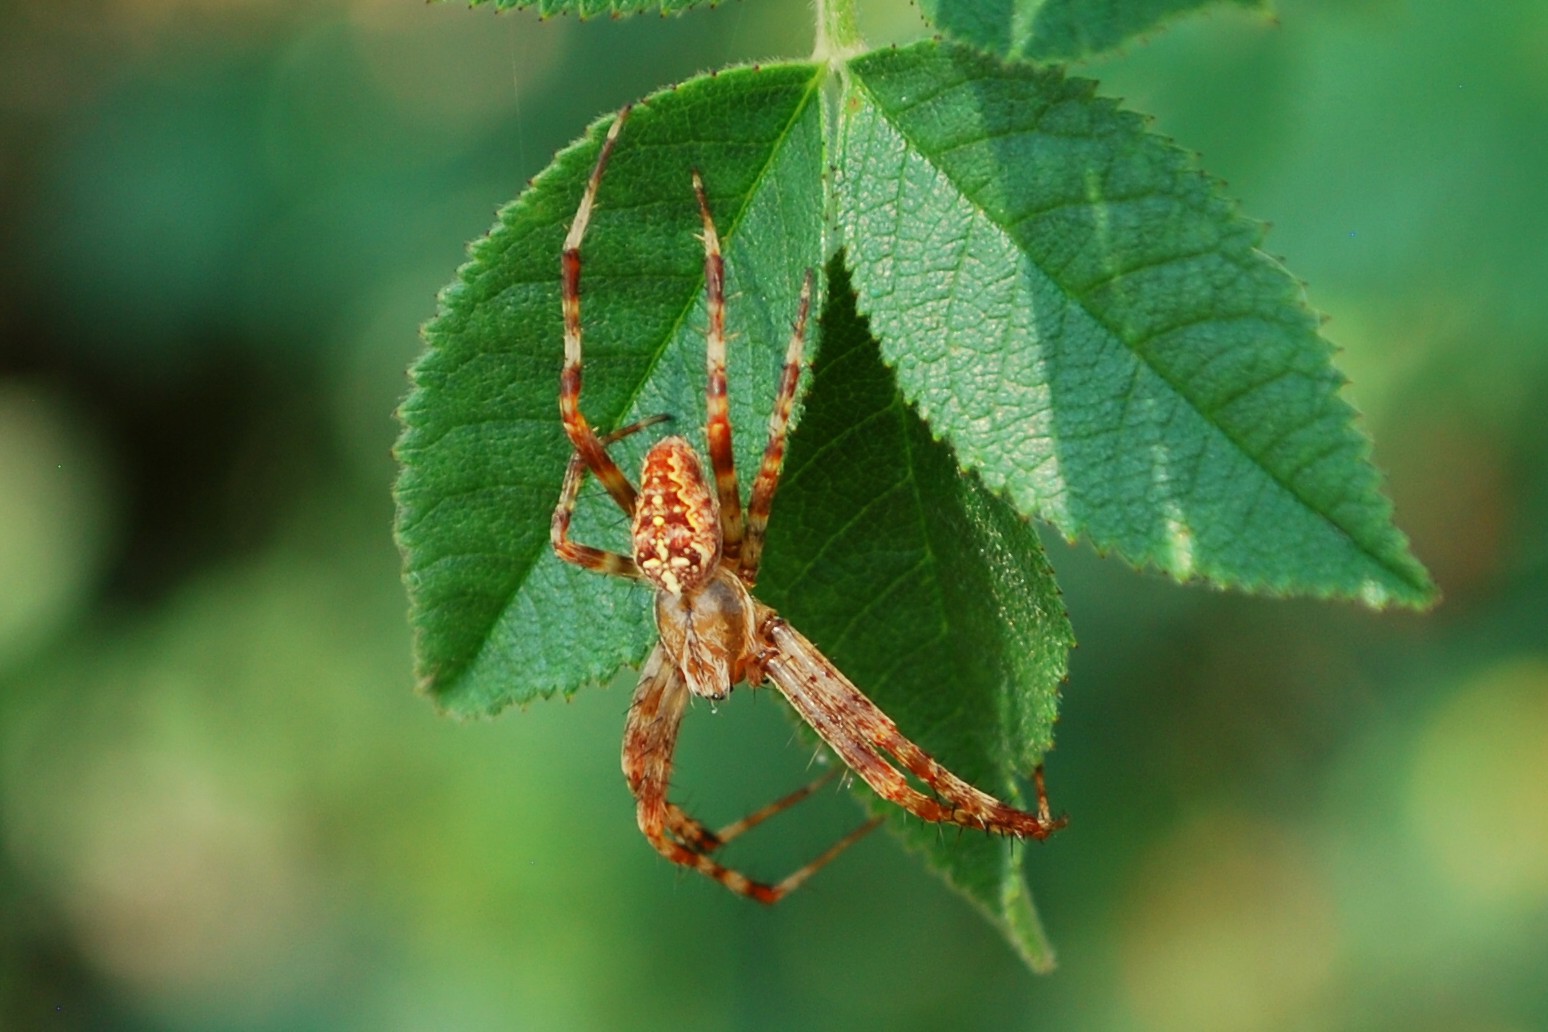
[{"xmin": 839, "ymin": 42, "xmax": 1435, "ymax": 607}]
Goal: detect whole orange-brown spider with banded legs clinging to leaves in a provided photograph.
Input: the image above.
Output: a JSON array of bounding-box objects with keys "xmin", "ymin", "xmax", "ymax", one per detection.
[{"xmin": 551, "ymin": 100, "xmax": 1065, "ymax": 904}]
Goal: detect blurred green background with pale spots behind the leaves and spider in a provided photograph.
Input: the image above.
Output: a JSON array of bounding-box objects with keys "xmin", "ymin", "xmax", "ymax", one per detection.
[{"xmin": 0, "ymin": 0, "xmax": 1548, "ymax": 1030}]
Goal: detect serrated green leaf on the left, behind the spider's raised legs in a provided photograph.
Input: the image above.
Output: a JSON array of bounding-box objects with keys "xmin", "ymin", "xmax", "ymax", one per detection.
[{"xmin": 396, "ymin": 65, "xmax": 824, "ymax": 715}]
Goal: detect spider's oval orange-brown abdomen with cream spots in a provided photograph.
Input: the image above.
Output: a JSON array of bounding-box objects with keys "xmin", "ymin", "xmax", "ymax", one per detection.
[{"xmin": 633, "ymin": 438, "xmax": 721, "ymax": 594}]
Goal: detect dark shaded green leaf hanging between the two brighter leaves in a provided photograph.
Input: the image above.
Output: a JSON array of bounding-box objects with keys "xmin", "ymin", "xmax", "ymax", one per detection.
[{"xmin": 759, "ymin": 260, "xmax": 1073, "ymax": 970}]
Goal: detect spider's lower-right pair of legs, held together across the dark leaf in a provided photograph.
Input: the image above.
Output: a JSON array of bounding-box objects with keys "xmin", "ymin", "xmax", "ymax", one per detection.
[{"xmin": 759, "ymin": 607, "xmax": 1063, "ymax": 839}]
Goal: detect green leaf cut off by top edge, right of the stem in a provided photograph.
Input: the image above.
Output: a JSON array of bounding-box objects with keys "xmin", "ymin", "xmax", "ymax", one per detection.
[{"xmin": 920, "ymin": 0, "xmax": 1265, "ymax": 60}]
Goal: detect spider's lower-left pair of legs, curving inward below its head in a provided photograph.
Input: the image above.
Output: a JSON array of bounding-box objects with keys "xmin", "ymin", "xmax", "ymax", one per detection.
[{"xmin": 622, "ymin": 645, "xmax": 879, "ymax": 904}]
